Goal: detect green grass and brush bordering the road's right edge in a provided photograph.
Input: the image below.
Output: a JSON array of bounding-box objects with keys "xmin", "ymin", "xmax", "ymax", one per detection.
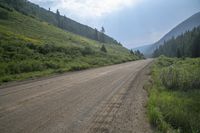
[{"xmin": 148, "ymin": 56, "xmax": 200, "ymax": 133}]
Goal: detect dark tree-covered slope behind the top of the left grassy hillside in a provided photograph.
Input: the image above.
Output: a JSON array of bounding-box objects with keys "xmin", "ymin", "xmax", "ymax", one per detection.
[{"xmin": 0, "ymin": 0, "xmax": 121, "ymax": 45}]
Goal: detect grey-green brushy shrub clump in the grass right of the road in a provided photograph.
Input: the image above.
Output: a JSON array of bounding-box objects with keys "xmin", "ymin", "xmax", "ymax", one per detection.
[{"xmin": 160, "ymin": 61, "xmax": 200, "ymax": 90}]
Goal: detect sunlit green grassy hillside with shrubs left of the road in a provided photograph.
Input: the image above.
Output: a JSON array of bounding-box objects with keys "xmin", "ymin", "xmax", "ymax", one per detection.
[{"xmin": 0, "ymin": 8, "xmax": 138, "ymax": 83}]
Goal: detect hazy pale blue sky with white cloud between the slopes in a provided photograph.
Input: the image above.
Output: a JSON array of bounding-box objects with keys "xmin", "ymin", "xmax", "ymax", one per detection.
[{"xmin": 30, "ymin": 0, "xmax": 200, "ymax": 48}]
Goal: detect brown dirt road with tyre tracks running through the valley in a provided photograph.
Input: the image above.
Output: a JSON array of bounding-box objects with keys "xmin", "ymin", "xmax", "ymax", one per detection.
[{"xmin": 0, "ymin": 59, "xmax": 152, "ymax": 133}]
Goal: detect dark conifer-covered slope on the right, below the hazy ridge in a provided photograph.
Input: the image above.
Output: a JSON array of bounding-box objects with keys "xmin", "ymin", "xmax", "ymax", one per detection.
[{"xmin": 153, "ymin": 27, "xmax": 200, "ymax": 57}]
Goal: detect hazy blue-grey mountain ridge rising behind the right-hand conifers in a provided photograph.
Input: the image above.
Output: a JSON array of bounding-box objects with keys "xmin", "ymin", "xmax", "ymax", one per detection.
[{"xmin": 134, "ymin": 12, "xmax": 200, "ymax": 57}]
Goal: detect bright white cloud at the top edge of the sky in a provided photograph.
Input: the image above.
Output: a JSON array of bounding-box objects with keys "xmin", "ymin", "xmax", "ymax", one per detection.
[{"xmin": 31, "ymin": 0, "xmax": 140, "ymax": 18}]
